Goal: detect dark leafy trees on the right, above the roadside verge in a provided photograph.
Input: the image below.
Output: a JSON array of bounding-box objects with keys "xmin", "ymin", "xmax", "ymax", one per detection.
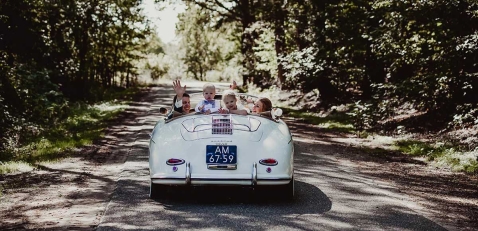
[{"xmin": 186, "ymin": 0, "xmax": 478, "ymax": 113}]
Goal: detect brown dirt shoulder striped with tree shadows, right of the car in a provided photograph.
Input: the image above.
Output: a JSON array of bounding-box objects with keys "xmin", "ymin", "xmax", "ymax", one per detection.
[{"xmin": 287, "ymin": 118, "xmax": 478, "ymax": 230}]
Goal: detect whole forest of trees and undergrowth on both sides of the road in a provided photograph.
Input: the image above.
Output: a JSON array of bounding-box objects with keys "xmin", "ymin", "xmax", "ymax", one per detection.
[{"xmin": 0, "ymin": 0, "xmax": 478, "ymax": 171}]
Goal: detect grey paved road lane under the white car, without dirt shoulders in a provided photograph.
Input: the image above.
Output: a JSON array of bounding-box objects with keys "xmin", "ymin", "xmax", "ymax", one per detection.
[{"xmin": 97, "ymin": 83, "xmax": 446, "ymax": 231}]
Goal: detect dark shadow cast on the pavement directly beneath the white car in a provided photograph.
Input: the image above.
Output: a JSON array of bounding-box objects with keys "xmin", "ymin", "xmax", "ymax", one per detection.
[{"xmin": 156, "ymin": 180, "xmax": 332, "ymax": 215}]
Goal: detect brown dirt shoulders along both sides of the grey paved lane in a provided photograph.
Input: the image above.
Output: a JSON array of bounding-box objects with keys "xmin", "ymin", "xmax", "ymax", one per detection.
[{"xmin": 0, "ymin": 84, "xmax": 478, "ymax": 230}]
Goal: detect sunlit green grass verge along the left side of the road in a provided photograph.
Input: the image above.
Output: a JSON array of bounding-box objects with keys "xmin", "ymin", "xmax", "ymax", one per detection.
[{"xmin": 0, "ymin": 101, "xmax": 127, "ymax": 174}]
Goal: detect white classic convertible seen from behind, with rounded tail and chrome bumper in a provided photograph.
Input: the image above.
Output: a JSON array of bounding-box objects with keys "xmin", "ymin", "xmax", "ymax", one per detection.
[{"xmin": 149, "ymin": 94, "xmax": 294, "ymax": 199}]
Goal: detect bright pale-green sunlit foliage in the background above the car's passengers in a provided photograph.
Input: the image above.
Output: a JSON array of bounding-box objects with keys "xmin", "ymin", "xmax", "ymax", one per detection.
[{"xmin": 152, "ymin": 4, "xmax": 242, "ymax": 81}]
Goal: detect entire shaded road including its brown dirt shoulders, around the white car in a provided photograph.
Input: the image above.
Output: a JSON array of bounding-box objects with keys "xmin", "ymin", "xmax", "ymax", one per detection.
[{"xmin": 0, "ymin": 82, "xmax": 478, "ymax": 231}]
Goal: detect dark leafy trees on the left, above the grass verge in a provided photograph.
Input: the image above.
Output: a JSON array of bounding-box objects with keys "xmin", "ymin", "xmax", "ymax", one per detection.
[{"xmin": 0, "ymin": 0, "xmax": 151, "ymax": 156}]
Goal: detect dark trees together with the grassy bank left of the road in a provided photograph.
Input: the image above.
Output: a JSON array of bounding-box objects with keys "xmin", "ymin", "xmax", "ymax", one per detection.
[{"xmin": 0, "ymin": 0, "xmax": 149, "ymax": 174}]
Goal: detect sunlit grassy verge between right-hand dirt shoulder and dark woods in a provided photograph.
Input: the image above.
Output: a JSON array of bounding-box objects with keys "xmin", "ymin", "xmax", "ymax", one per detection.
[{"xmin": 247, "ymin": 84, "xmax": 478, "ymax": 174}]
